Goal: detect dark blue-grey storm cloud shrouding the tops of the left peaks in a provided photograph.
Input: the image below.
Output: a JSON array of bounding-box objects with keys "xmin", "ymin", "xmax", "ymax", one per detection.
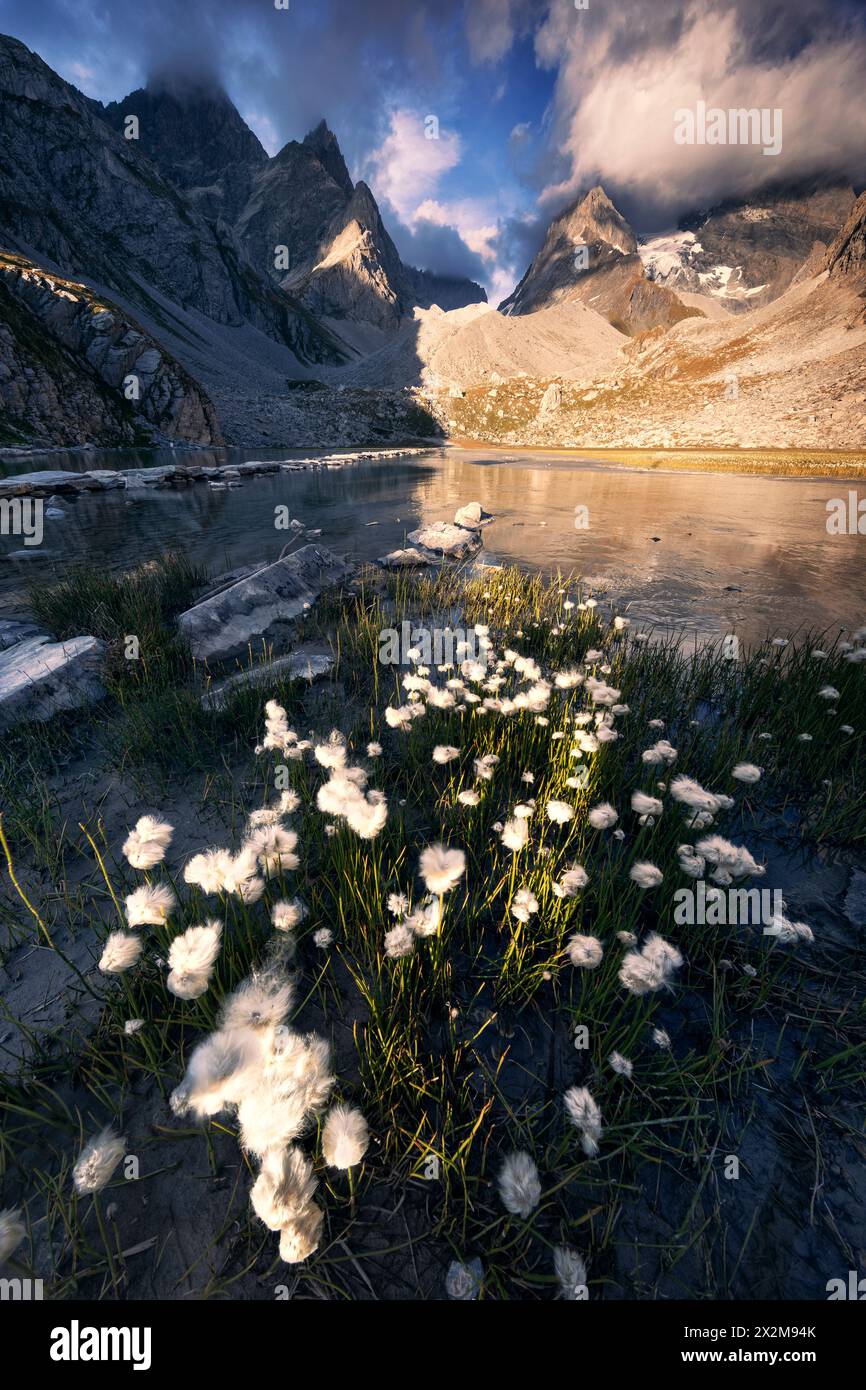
[{"xmin": 0, "ymin": 0, "xmax": 461, "ymax": 158}]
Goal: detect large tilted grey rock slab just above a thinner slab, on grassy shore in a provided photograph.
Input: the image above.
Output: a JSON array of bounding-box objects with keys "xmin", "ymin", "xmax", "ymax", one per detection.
[{"xmin": 178, "ymin": 545, "xmax": 349, "ymax": 663}]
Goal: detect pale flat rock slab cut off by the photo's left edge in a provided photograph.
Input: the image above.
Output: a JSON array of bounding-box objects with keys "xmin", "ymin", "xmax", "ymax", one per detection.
[{"xmin": 0, "ymin": 637, "xmax": 106, "ymax": 728}]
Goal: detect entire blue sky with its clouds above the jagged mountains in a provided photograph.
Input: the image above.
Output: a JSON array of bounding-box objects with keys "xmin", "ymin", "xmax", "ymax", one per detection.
[{"xmin": 0, "ymin": 0, "xmax": 866, "ymax": 302}]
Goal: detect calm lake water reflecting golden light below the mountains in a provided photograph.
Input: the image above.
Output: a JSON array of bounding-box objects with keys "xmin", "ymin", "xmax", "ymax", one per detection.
[{"xmin": 0, "ymin": 449, "xmax": 866, "ymax": 642}]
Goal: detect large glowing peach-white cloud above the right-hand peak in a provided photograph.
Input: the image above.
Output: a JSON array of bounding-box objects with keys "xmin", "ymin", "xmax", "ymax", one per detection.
[{"xmin": 537, "ymin": 0, "xmax": 866, "ymax": 209}]
